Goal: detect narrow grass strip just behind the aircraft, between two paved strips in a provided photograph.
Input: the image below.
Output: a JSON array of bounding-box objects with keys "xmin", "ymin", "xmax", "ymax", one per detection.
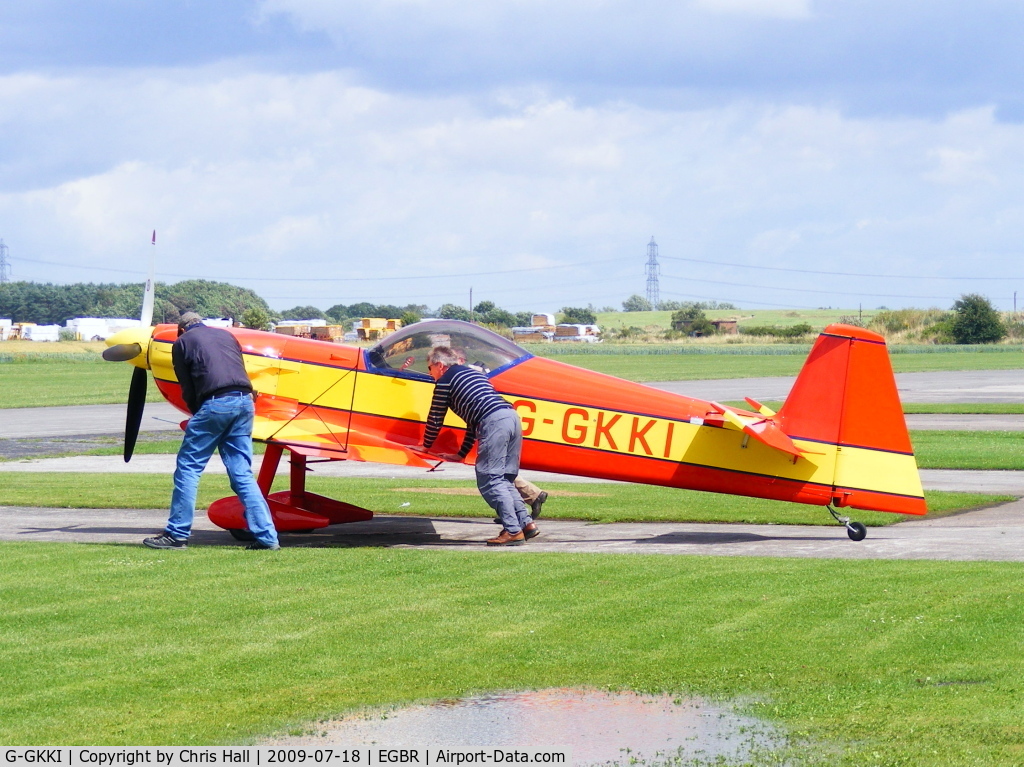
[{"xmin": 0, "ymin": 472, "xmax": 1013, "ymax": 525}]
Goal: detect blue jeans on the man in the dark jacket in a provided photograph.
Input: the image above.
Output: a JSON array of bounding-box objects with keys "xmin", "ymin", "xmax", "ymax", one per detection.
[{"xmin": 167, "ymin": 395, "xmax": 278, "ymax": 546}]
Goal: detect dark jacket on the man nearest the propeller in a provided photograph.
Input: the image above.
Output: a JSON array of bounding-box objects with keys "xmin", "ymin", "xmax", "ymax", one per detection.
[{"xmin": 171, "ymin": 324, "xmax": 253, "ymax": 415}]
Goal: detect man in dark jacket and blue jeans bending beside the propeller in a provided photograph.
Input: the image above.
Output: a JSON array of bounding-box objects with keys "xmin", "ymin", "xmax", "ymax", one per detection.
[{"xmin": 142, "ymin": 311, "xmax": 281, "ymax": 549}]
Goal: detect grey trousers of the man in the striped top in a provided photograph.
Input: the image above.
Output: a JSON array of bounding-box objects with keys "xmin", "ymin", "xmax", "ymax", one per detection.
[{"xmin": 476, "ymin": 409, "xmax": 534, "ymax": 536}]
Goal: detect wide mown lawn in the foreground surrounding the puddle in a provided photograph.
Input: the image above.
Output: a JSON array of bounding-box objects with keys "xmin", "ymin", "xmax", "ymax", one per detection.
[{"xmin": 0, "ymin": 544, "xmax": 1024, "ymax": 766}]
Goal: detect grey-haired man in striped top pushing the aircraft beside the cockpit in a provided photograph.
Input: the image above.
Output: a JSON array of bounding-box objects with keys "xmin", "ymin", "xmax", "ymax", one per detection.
[{"xmin": 423, "ymin": 346, "xmax": 539, "ymax": 546}]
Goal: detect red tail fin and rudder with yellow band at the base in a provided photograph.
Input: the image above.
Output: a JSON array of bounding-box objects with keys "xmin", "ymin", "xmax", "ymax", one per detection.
[{"xmin": 775, "ymin": 325, "xmax": 927, "ymax": 514}]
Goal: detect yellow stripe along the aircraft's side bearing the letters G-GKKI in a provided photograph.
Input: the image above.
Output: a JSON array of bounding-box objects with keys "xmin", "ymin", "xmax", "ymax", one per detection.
[{"xmin": 151, "ymin": 344, "xmax": 924, "ymax": 498}]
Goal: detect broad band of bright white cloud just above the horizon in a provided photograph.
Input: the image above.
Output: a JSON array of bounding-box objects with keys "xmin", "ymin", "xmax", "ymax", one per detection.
[{"xmin": 0, "ymin": 68, "xmax": 1024, "ymax": 310}]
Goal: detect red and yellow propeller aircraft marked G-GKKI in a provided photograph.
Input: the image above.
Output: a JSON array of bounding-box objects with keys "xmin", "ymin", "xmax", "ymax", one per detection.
[{"xmin": 103, "ymin": 319, "xmax": 926, "ymax": 541}]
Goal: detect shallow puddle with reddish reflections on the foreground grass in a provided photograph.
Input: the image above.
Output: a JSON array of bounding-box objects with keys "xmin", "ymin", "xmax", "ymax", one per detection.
[{"xmin": 268, "ymin": 689, "xmax": 785, "ymax": 765}]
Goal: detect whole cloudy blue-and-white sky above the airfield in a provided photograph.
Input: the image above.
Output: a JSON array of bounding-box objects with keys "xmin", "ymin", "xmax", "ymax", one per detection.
[{"xmin": 0, "ymin": 0, "xmax": 1024, "ymax": 311}]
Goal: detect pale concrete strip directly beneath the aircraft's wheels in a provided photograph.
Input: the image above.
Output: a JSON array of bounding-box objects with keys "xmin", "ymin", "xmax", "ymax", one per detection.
[{"xmin": 0, "ymin": 493, "xmax": 1024, "ymax": 561}]
